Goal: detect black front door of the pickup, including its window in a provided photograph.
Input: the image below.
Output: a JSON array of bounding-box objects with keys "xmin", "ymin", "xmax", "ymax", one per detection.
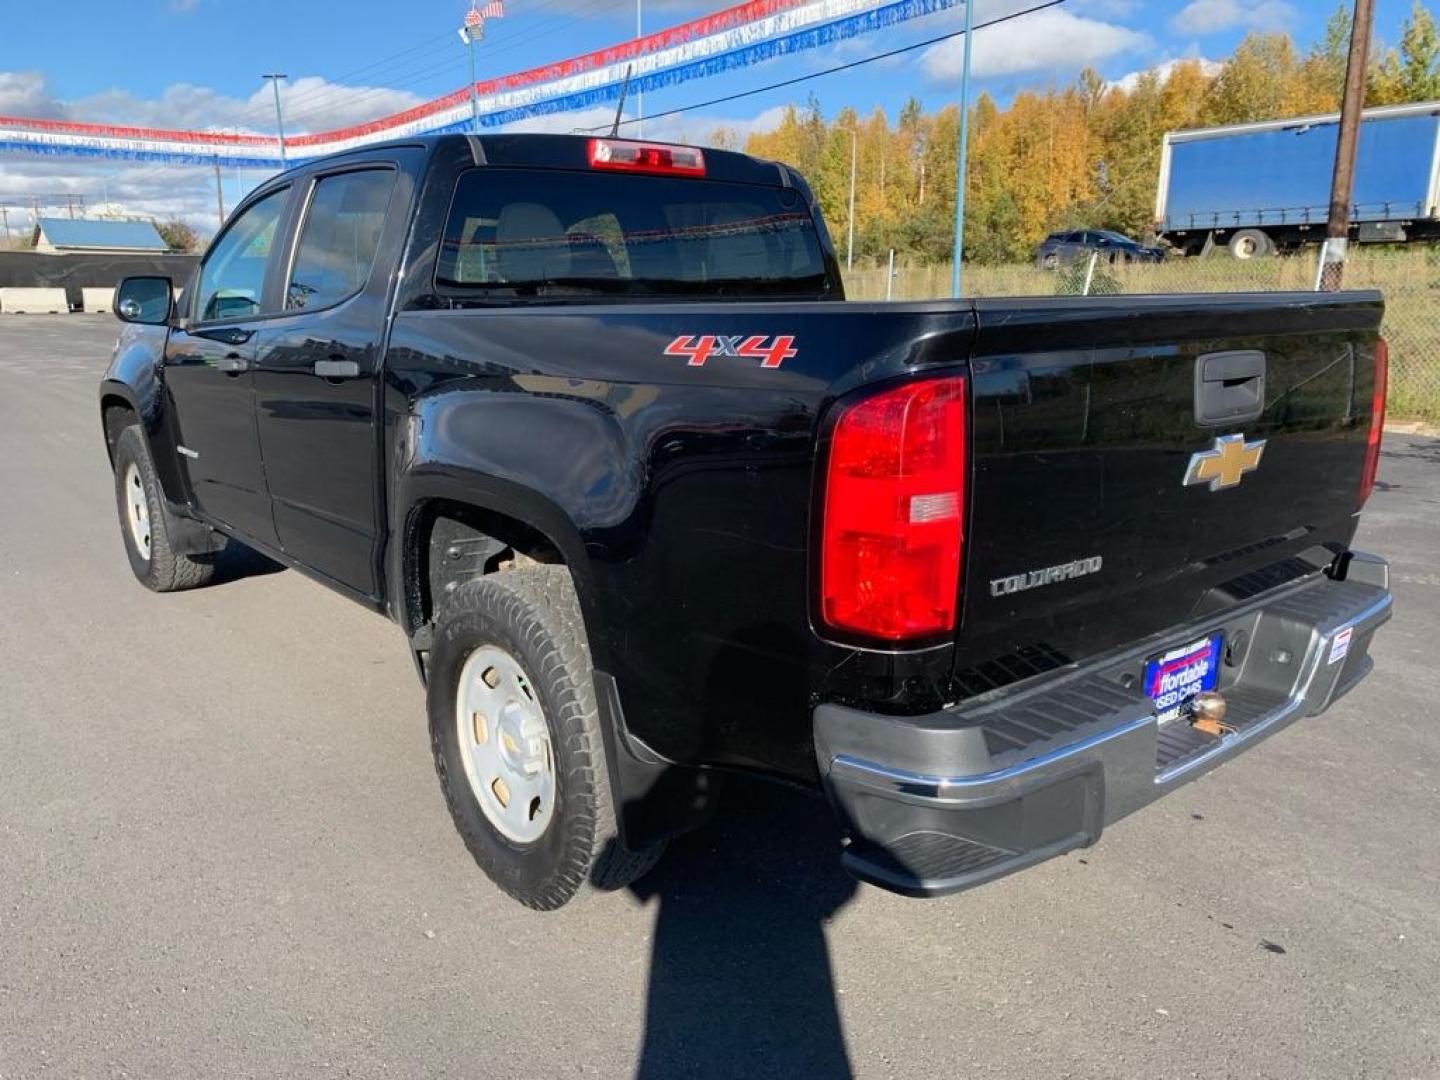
[{"xmin": 164, "ymin": 189, "xmax": 289, "ymax": 544}]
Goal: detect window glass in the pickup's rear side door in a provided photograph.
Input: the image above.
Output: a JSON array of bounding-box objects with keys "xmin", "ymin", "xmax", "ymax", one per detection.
[{"xmin": 285, "ymin": 168, "xmax": 395, "ymax": 311}]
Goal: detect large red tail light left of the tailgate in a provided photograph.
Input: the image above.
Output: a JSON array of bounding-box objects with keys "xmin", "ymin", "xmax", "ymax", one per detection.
[{"xmin": 819, "ymin": 377, "xmax": 966, "ymax": 641}]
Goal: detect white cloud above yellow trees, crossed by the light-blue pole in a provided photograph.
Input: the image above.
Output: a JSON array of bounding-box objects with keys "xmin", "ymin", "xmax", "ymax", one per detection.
[{"xmin": 920, "ymin": 7, "xmax": 1152, "ymax": 84}]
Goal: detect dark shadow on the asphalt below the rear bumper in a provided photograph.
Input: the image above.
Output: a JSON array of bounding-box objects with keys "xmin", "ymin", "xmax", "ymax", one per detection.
[{"xmin": 631, "ymin": 780, "xmax": 855, "ymax": 1080}]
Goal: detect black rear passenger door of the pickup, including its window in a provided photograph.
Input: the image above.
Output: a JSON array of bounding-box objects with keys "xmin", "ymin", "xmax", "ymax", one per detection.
[{"xmin": 255, "ymin": 167, "xmax": 406, "ymax": 596}]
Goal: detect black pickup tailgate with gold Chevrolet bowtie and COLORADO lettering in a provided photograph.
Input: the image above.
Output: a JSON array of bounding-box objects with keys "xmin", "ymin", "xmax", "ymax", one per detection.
[{"xmin": 956, "ymin": 294, "xmax": 1382, "ymax": 697}]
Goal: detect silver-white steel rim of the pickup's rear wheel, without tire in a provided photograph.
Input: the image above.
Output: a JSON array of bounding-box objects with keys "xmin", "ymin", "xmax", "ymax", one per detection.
[{"xmin": 455, "ymin": 645, "xmax": 556, "ymax": 844}]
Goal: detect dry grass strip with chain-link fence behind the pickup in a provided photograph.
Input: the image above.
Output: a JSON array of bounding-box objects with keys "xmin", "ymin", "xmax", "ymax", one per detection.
[{"xmin": 845, "ymin": 248, "xmax": 1440, "ymax": 420}]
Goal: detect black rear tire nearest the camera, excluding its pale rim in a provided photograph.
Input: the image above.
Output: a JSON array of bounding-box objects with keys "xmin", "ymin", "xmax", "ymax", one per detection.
[{"xmin": 426, "ymin": 566, "xmax": 664, "ymax": 912}]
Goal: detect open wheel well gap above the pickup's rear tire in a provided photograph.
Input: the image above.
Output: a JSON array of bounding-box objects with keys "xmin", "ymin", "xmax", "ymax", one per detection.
[{"xmin": 406, "ymin": 500, "xmax": 564, "ymax": 635}]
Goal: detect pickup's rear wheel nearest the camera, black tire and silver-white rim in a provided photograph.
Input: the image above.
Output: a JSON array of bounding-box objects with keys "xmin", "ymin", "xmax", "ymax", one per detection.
[{"xmin": 426, "ymin": 566, "xmax": 662, "ymax": 910}]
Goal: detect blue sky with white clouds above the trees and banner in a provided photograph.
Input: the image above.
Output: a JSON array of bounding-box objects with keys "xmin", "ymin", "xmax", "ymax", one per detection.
[{"xmin": 0, "ymin": 0, "xmax": 1434, "ymax": 228}]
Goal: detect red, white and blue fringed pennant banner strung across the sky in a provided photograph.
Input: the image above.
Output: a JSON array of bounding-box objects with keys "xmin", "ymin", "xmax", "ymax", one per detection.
[{"xmin": 0, "ymin": 0, "xmax": 962, "ymax": 168}]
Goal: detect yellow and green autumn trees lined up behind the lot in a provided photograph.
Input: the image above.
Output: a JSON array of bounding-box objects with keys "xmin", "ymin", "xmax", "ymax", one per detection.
[{"xmin": 708, "ymin": 0, "xmax": 1440, "ymax": 262}]
